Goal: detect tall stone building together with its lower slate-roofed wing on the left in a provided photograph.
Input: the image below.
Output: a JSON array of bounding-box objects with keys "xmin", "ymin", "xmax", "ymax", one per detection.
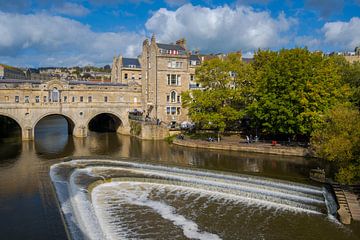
[{"xmin": 111, "ymin": 36, "xmax": 201, "ymax": 126}]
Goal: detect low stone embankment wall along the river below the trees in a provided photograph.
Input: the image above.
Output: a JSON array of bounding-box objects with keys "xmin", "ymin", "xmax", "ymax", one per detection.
[{"xmin": 173, "ymin": 136, "xmax": 310, "ymax": 157}]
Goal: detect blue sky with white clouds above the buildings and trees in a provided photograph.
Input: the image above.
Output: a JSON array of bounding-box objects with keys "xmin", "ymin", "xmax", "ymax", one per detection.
[{"xmin": 0, "ymin": 0, "xmax": 360, "ymax": 67}]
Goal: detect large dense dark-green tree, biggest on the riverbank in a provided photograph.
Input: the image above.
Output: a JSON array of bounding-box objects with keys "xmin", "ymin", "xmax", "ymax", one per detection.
[{"xmin": 247, "ymin": 48, "xmax": 348, "ymax": 140}]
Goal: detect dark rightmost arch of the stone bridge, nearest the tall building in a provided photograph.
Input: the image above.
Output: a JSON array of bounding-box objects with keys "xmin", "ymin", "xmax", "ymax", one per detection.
[{"xmin": 86, "ymin": 111, "xmax": 124, "ymax": 132}]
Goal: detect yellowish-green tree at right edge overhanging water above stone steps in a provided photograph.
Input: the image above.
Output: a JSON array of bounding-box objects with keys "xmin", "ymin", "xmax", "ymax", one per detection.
[{"xmin": 311, "ymin": 105, "xmax": 360, "ymax": 184}]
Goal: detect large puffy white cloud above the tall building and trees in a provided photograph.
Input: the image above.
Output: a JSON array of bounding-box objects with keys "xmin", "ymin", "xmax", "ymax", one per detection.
[{"xmin": 145, "ymin": 4, "xmax": 296, "ymax": 51}]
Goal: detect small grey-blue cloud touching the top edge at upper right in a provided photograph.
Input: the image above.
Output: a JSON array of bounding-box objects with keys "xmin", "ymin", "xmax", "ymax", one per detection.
[{"xmin": 305, "ymin": 0, "xmax": 344, "ymax": 18}]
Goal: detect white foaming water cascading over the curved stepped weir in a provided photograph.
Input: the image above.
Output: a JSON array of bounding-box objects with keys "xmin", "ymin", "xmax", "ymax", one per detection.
[{"xmin": 50, "ymin": 160, "xmax": 334, "ymax": 239}]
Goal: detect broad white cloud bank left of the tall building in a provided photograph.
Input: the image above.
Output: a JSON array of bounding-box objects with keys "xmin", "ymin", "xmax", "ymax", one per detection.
[{"xmin": 0, "ymin": 12, "xmax": 144, "ymax": 66}]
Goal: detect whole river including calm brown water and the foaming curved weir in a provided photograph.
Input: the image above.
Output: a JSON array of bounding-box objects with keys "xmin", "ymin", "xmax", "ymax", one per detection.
[{"xmin": 0, "ymin": 117, "xmax": 360, "ymax": 239}]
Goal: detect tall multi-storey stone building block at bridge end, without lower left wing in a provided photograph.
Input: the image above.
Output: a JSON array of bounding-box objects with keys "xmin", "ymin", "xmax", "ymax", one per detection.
[{"xmin": 140, "ymin": 36, "xmax": 200, "ymax": 126}]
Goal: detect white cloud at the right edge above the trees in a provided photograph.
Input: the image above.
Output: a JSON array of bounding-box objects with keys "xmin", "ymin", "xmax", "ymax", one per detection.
[{"xmin": 322, "ymin": 17, "xmax": 360, "ymax": 50}]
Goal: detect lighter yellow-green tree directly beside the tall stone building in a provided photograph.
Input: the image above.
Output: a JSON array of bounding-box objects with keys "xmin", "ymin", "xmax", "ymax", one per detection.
[{"xmin": 182, "ymin": 53, "xmax": 251, "ymax": 139}]
